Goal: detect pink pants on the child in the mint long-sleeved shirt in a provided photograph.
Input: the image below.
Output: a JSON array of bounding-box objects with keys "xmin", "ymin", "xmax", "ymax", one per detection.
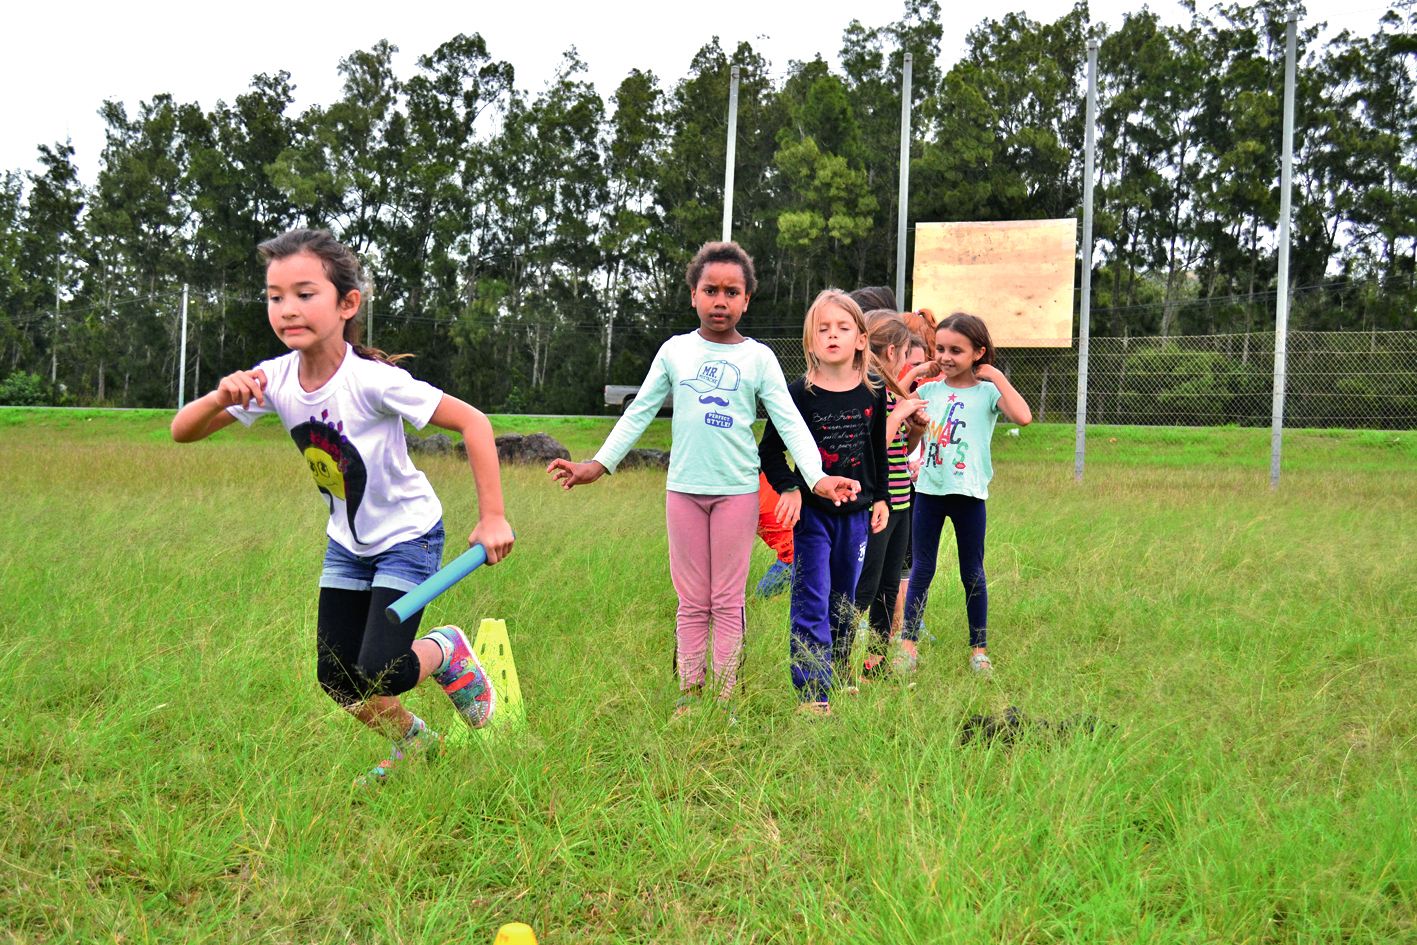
[{"xmin": 665, "ymin": 492, "xmax": 758, "ymax": 698}]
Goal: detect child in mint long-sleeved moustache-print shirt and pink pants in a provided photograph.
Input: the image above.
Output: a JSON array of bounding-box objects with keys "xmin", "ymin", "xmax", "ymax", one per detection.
[{"xmin": 547, "ymin": 242, "xmax": 859, "ymax": 714}]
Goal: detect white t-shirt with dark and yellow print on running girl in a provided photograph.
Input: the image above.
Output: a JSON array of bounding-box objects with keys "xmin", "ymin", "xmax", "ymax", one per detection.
[{"xmin": 227, "ymin": 346, "xmax": 442, "ymax": 557}]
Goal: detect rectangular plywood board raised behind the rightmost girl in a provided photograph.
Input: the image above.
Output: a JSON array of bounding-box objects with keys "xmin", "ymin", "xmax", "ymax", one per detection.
[{"xmin": 911, "ymin": 218, "xmax": 1077, "ymax": 349}]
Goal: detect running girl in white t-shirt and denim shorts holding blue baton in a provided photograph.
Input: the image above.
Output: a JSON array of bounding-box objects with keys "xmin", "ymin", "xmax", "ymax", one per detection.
[{"xmin": 171, "ymin": 230, "xmax": 513, "ymax": 785}]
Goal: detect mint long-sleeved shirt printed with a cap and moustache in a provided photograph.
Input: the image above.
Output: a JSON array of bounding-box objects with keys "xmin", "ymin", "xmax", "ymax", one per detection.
[{"xmin": 595, "ymin": 332, "xmax": 823, "ymax": 496}]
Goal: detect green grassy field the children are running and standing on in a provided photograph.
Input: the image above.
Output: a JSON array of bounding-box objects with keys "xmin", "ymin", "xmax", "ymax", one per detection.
[{"xmin": 0, "ymin": 411, "xmax": 1417, "ymax": 945}]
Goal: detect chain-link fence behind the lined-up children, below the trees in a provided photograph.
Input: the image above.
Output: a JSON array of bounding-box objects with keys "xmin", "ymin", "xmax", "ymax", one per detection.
[{"xmin": 764, "ymin": 332, "xmax": 1417, "ymax": 429}]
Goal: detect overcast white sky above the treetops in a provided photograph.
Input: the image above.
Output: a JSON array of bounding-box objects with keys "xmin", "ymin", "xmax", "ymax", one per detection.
[{"xmin": 0, "ymin": 0, "xmax": 1389, "ymax": 180}]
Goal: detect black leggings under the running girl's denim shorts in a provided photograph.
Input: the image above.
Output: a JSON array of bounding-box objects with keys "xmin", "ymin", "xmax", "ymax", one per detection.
[{"xmin": 315, "ymin": 588, "xmax": 424, "ymax": 706}]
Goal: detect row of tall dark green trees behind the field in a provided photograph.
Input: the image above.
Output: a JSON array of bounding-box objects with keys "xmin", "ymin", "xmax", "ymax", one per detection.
[{"xmin": 0, "ymin": 0, "xmax": 1417, "ymax": 412}]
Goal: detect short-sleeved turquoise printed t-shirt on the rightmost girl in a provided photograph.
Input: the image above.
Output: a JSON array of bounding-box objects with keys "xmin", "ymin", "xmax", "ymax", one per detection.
[{"xmin": 915, "ymin": 380, "xmax": 1002, "ymax": 499}]
